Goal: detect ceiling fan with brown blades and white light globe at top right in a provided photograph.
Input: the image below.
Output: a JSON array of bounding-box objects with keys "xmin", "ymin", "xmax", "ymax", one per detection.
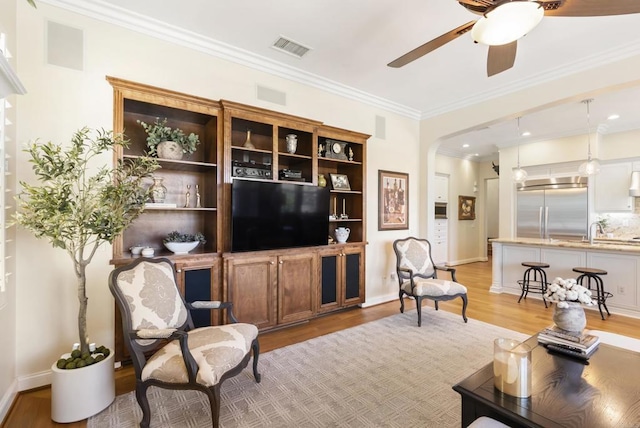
[{"xmin": 387, "ymin": 0, "xmax": 640, "ymax": 77}]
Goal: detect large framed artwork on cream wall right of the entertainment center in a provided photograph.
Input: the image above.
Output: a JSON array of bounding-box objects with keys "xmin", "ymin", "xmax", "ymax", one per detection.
[{"xmin": 378, "ymin": 170, "xmax": 409, "ymax": 230}]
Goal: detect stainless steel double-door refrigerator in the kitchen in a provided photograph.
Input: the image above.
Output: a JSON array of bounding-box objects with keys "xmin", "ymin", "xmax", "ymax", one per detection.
[{"xmin": 516, "ymin": 177, "xmax": 589, "ymax": 239}]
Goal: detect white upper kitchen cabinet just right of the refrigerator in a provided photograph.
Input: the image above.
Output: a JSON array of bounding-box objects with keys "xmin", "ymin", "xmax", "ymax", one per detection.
[{"xmin": 594, "ymin": 162, "xmax": 633, "ymax": 213}]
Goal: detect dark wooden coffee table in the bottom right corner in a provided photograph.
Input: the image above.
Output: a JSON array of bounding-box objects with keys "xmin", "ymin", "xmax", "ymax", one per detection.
[{"xmin": 453, "ymin": 336, "xmax": 640, "ymax": 428}]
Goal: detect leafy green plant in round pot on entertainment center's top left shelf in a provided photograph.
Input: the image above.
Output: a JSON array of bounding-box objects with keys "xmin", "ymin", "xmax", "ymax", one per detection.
[{"xmin": 138, "ymin": 117, "xmax": 200, "ymax": 160}]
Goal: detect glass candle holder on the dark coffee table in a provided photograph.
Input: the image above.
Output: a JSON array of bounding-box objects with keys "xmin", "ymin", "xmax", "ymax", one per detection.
[{"xmin": 493, "ymin": 338, "xmax": 531, "ymax": 398}]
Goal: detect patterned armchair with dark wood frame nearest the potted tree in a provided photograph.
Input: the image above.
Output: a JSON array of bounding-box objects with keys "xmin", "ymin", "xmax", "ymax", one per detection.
[{"xmin": 109, "ymin": 258, "xmax": 260, "ymax": 427}]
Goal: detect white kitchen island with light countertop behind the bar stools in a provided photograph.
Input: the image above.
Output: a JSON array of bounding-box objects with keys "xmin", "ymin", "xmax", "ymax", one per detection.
[{"xmin": 490, "ymin": 238, "xmax": 640, "ymax": 318}]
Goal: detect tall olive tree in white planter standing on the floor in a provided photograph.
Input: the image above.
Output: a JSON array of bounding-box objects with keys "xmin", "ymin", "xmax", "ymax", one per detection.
[{"xmin": 14, "ymin": 127, "xmax": 158, "ymax": 422}]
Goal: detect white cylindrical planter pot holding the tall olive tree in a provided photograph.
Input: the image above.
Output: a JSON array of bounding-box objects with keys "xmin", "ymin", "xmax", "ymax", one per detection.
[{"xmin": 51, "ymin": 350, "xmax": 116, "ymax": 423}]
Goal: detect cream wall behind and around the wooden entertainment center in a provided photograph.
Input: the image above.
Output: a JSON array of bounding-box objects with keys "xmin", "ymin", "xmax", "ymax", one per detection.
[{"xmin": 15, "ymin": 2, "xmax": 419, "ymax": 389}]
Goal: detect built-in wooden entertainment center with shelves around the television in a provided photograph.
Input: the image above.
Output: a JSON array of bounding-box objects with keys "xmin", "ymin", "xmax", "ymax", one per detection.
[{"xmin": 107, "ymin": 77, "xmax": 369, "ymax": 361}]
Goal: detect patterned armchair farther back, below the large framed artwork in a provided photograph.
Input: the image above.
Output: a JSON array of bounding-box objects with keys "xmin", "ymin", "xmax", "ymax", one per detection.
[{"xmin": 393, "ymin": 237, "xmax": 467, "ymax": 326}]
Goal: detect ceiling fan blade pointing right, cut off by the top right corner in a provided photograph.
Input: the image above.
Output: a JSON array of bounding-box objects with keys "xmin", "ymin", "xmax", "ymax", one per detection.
[{"xmin": 542, "ymin": 0, "xmax": 640, "ymax": 16}]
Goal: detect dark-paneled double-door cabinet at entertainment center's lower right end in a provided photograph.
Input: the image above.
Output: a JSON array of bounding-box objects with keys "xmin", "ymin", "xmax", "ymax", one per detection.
[{"xmin": 318, "ymin": 244, "xmax": 364, "ymax": 313}]
